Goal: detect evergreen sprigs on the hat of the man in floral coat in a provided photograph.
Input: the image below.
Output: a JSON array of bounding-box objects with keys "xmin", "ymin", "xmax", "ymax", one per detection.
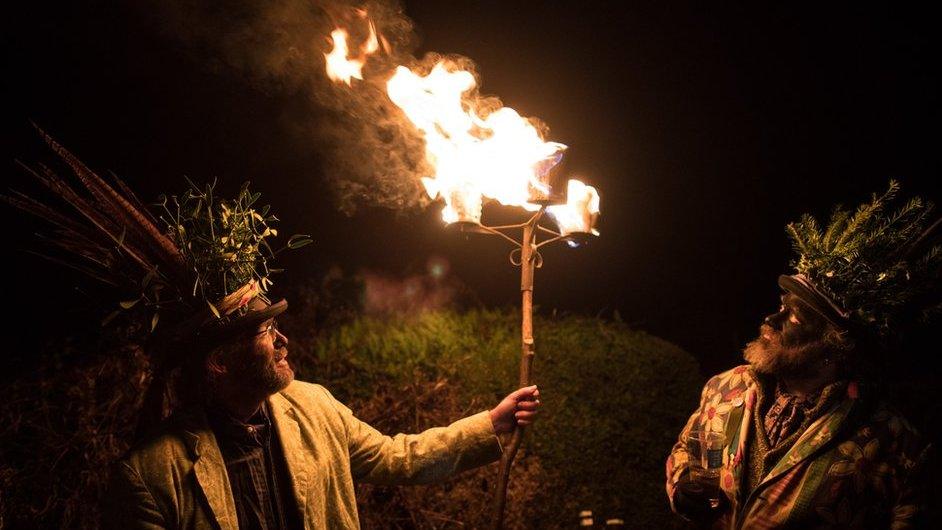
[{"xmin": 786, "ymin": 180, "xmax": 942, "ymax": 335}]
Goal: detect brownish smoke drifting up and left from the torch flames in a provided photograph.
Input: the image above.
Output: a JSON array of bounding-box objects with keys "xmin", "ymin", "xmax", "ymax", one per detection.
[{"xmin": 147, "ymin": 0, "xmax": 437, "ymax": 213}]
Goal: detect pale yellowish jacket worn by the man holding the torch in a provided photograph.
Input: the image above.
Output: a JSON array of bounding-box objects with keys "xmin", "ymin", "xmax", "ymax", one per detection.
[{"xmin": 105, "ymin": 381, "xmax": 501, "ymax": 530}]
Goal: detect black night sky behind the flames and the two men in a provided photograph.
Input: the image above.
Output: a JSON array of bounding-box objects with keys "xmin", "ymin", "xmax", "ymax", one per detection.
[{"xmin": 0, "ymin": 0, "xmax": 942, "ymax": 378}]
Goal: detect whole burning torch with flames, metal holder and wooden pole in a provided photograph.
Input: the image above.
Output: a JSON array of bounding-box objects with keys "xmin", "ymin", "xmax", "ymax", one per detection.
[{"xmin": 325, "ymin": 12, "xmax": 599, "ymax": 528}]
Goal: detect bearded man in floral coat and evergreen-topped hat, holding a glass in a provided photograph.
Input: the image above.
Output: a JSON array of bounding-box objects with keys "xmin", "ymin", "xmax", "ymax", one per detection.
[{"xmin": 666, "ymin": 183, "xmax": 942, "ymax": 529}]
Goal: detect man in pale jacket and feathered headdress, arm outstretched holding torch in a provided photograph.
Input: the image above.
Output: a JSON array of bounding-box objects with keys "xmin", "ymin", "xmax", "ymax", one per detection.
[{"xmin": 3, "ymin": 131, "xmax": 540, "ymax": 530}]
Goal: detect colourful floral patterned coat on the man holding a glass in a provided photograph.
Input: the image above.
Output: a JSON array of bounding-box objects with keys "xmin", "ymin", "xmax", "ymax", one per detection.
[{"xmin": 667, "ymin": 366, "xmax": 929, "ymax": 529}]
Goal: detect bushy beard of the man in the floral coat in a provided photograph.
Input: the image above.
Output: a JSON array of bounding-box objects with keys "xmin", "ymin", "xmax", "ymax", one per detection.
[{"xmin": 743, "ymin": 325, "xmax": 827, "ymax": 379}]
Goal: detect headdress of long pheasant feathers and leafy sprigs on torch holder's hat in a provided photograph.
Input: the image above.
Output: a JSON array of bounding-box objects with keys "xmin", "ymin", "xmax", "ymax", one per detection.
[{"xmin": 3, "ymin": 127, "xmax": 311, "ymax": 354}]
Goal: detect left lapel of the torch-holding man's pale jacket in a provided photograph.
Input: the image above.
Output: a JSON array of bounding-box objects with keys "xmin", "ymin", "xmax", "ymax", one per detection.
[{"xmin": 184, "ymin": 411, "xmax": 239, "ymax": 530}]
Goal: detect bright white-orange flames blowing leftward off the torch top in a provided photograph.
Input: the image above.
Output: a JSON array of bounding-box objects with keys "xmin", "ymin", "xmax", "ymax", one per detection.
[{"xmin": 324, "ymin": 10, "xmax": 598, "ymax": 223}]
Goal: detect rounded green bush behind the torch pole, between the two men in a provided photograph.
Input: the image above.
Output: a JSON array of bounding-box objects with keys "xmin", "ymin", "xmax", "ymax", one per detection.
[{"xmin": 300, "ymin": 310, "xmax": 700, "ymax": 528}]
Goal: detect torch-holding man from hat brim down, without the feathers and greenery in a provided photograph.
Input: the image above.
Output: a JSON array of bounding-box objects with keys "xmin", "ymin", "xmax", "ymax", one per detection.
[{"xmin": 106, "ymin": 294, "xmax": 540, "ymax": 529}]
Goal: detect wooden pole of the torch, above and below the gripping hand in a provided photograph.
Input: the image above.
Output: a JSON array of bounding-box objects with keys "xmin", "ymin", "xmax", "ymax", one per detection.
[{"xmin": 493, "ymin": 212, "xmax": 542, "ymax": 530}]
